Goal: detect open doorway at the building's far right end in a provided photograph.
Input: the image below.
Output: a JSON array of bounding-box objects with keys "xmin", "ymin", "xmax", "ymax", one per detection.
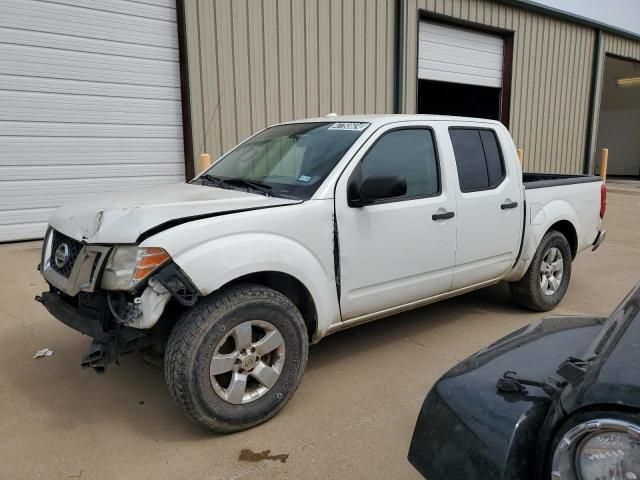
[{"xmin": 597, "ymin": 55, "xmax": 640, "ymax": 179}]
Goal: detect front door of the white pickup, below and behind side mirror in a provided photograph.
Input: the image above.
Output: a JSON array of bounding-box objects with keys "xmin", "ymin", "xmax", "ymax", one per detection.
[{"xmin": 336, "ymin": 123, "xmax": 457, "ymax": 320}]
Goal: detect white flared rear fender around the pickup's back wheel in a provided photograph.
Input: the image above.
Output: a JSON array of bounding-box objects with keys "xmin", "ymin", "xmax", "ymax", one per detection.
[{"xmin": 505, "ymin": 199, "xmax": 580, "ymax": 282}]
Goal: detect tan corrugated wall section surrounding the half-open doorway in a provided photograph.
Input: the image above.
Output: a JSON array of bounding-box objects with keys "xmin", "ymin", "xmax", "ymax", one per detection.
[{"xmin": 403, "ymin": 0, "xmax": 595, "ymax": 173}]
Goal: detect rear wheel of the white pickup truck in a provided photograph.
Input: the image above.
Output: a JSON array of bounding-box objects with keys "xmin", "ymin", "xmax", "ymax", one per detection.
[{"xmin": 509, "ymin": 230, "xmax": 571, "ymax": 312}]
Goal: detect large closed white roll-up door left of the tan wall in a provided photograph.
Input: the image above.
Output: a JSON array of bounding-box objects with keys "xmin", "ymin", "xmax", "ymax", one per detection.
[{"xmin": 0, "ymin": 0, "xmax": 185, "ymax": 241}]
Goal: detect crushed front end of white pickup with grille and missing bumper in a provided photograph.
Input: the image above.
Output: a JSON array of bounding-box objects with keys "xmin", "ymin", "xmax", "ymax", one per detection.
[{"xmin": 36, "ymin": 228, "xmax": 198, "ymax": 372}]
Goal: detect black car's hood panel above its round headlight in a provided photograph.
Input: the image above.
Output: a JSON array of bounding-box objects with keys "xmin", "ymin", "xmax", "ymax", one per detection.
[{"xmin": 560, "ymin": 284, "xmax": 640, "ymax": 414}]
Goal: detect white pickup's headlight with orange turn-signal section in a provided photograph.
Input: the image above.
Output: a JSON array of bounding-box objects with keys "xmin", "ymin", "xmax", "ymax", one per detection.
[{"xmin": 100, "ymin": 245, "xmax": 171, "ymax": 290}]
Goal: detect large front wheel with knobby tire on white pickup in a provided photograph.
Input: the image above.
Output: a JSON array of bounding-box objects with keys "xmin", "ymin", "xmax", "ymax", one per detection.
[{"xmin": 164, "ymin": 284, "xmax": 309, "ymax": 433}]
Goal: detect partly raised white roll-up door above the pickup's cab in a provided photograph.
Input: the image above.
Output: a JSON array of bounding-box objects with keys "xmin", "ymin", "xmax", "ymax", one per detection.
[{"xmin": 418, "ymin": 21, "xmax": 504, "ymax": 88}]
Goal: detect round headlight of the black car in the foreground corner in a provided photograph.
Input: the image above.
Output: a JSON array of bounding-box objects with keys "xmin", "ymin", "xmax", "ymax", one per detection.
[{"xmin": 551, "ymin": 419, "xmax": 640, "ymax": 480}]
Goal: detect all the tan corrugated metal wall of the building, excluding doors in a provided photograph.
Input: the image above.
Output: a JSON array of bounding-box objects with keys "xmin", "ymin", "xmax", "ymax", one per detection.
[{"xmin": 185, "ymin": 0, "xmax": 640, "ymax": 173}]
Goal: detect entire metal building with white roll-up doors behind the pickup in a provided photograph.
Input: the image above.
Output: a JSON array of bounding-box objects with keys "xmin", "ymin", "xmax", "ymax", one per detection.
[{"xmin": 0, "ymin": 0, "xmax": 640, "ymax": 241}]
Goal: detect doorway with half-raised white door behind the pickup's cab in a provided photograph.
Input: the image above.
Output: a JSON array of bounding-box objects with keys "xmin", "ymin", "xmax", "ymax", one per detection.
[{"xmin": 417, "ymin": 19, "xmax": 512, "ymax": 126}]
